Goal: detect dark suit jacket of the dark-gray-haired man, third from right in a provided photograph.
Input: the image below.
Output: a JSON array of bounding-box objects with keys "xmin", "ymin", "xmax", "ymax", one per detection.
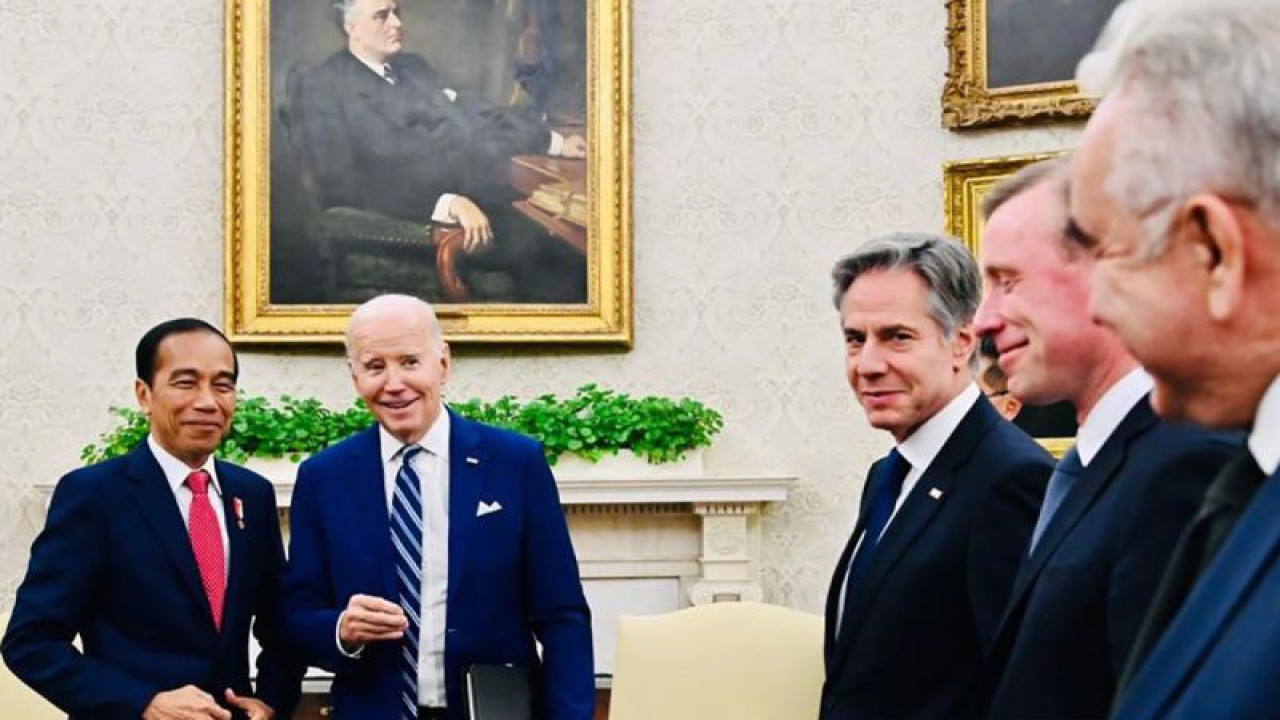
[{"xmin": 820, "ymin": 397, "xmax": 1053, "ymax": 720}]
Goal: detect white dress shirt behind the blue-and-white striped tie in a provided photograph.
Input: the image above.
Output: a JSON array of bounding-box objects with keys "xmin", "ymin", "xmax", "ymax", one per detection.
[{"xmin": 378, "ymin": 407, "xmax": 451, "ymax": 707}]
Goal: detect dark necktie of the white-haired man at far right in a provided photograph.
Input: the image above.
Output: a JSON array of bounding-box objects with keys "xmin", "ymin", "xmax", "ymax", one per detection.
[{"xmin": 1117, "ymin": 447, "xmax": 1266, "ymax": 697}]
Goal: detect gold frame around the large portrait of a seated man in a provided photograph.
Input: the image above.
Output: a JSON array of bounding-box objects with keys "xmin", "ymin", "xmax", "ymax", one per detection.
[{"xmin": 223, "ymin": 0, "xmax": 635, "ymax": 348}]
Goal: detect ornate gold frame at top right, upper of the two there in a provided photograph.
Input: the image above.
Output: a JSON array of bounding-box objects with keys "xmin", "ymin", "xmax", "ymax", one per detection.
[{"xmin": 942, "ymin": 0, "xmax": 1098, "ymax": 129}]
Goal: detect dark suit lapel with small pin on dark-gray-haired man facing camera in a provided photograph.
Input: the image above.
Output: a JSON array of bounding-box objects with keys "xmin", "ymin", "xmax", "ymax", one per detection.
[{"xmin": 837, "ymin": 397, "xmax": 998, "ymax": 661}]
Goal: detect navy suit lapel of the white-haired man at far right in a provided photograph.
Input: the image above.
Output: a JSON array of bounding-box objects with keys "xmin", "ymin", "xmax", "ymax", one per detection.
[{"xmin": 1128, "ymin": 471, "xmax": 1280, "ymax": 715}]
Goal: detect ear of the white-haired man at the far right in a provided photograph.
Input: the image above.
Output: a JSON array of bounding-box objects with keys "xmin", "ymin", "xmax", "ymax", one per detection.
[{"xmin": 1183, "ymin": 193, "xmax": 1248, "ymax": 320}]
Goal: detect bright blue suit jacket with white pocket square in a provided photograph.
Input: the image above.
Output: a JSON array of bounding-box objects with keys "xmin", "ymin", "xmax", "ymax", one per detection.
[{"xmin": 282, "ymin": 411, "xmax": 595, "ymax": 720}]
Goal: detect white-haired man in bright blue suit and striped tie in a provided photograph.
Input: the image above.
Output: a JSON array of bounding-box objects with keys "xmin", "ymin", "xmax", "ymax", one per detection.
[{"xmin": 283, "ymin": 295, "xmax": 595, "ymax": 720}]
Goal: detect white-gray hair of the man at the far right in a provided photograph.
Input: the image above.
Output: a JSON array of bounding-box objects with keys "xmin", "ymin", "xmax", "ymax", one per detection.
[{"xmin": 1076, "ymin": 0, "xmax": 1280, "ymax": 256}]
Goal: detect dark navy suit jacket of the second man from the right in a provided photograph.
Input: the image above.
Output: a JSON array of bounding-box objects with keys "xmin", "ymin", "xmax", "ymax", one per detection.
[{"xmin": 988, "ymin": 397, "xmax": 1240, "ymax": 719}]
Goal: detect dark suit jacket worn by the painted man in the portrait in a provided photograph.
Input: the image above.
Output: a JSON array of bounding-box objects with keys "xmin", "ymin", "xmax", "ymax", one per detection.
[{"xmin": 294, "ymin": 50, "xmax": 552, "ymax": 223}]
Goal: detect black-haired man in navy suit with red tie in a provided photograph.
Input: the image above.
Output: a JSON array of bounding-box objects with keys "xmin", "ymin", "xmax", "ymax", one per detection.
[{"xmin": 4, "ymin": 319, "xmax": 303, "ymax": 720}]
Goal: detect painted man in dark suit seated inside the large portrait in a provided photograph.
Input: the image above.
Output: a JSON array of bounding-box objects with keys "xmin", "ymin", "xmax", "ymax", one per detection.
[{"xmin": 296, "ymin": 0, "xmax": 586, "ymax": 304}]
